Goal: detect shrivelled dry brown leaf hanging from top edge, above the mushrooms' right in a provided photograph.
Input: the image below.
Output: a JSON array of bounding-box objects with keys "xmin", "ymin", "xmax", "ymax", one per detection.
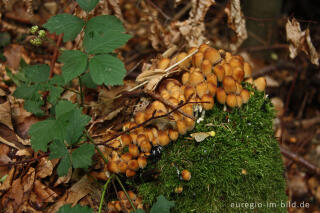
[{"xmin": 225, "ymin": 0, "xmax": 248, "ymax": 51}]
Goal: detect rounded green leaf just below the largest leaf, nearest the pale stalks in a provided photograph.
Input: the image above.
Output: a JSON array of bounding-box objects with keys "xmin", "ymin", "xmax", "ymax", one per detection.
[{"xmin": 89, "ymin": 54, "xmax": 126, "ymax": 86}]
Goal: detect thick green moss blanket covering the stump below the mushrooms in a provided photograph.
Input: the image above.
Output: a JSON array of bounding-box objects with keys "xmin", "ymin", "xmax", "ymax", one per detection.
[{"xmin": 137, "ymin": 92, "xmax": 287, "ymax": 213}]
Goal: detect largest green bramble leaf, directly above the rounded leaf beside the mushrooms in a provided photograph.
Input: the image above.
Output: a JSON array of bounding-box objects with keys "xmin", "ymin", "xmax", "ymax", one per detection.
[{"xmin": 83, "ymin": 15, "xmax": 131, "ymax": 54}]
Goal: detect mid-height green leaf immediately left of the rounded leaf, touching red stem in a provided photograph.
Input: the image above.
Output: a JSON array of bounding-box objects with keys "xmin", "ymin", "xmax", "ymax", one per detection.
[{"xmin": 59, "ymin": 50, "xmax": 88, "ymax": 82}]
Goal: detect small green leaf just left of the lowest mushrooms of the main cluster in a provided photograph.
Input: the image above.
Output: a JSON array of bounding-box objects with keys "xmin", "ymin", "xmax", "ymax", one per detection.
[{"xmin": 71, "ymin": 143, "xmax": 94, "ymax": 169}]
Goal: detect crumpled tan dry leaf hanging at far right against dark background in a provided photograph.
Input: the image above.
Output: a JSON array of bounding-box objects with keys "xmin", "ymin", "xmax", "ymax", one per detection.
[{"xmin": 286, "ymin": 18, "xmax": 319, "ymax": 66}]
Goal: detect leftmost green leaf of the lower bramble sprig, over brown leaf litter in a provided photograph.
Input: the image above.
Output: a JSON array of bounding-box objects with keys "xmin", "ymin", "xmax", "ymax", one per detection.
[{"xmin": 29, "ymin": 120, "xmax": 57, "ymax": 152}]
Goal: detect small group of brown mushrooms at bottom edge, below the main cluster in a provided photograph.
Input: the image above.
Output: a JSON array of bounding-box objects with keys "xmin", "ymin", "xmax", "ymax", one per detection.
[{"xmin": 107, "ymin": 191, "xmax": 143, "ymax": 213}]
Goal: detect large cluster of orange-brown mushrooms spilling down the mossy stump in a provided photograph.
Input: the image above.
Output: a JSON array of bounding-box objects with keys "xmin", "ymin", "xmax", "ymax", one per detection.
[{"xmin": 102, "ymin": 44, "xmax": 266, "ymax": 211}]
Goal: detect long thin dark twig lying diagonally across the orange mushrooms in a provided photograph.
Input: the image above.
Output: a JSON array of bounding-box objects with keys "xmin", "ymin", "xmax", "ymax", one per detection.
[{"xmin": 96, "ymin": 100, "xmax": 208, "ymax": 146}]
